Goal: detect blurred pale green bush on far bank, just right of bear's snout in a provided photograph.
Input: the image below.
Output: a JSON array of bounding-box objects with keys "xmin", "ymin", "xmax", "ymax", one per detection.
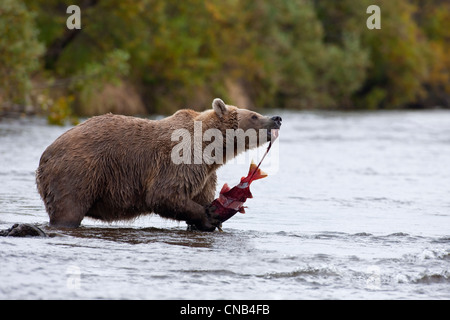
[{"xmin": 264, "ymin": 0, "xmax": 368, "ymax": 108}]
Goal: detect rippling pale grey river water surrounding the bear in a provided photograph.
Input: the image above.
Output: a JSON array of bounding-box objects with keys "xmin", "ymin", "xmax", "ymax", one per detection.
[{"xmin": 0, "ymin": 110, "xmax": 450, "ymax": 299}]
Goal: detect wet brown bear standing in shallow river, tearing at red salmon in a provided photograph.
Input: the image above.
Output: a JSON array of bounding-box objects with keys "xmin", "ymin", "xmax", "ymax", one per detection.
[{"xmin": 36, "ymin": 99, "xmax": 281, "ymax": 231}]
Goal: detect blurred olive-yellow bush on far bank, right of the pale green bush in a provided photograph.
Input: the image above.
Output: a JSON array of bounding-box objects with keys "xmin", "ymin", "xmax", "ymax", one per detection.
[{"xmin": 364, "ymin": 1, "xmax": 430, "ymax": 107}]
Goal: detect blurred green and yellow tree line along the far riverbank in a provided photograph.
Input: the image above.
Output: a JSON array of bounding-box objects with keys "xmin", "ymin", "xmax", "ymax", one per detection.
[{"xmin": 0, "ymin": 0, "xmax": 450, "ymax": 123}]
